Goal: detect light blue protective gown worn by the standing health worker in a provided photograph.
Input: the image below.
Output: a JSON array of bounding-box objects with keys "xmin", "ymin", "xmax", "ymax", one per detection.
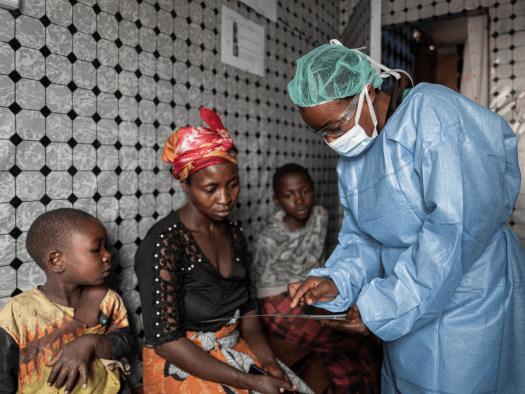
[{"xmin": 310, "ymin": 84, "xmax": 525, "ymax": 394}]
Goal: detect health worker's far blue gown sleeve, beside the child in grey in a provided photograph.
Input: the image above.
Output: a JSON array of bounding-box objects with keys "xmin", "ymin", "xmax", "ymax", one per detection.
[{"xmin": 309, "ymin": 182, "xmax": 382, "ymax": 312}]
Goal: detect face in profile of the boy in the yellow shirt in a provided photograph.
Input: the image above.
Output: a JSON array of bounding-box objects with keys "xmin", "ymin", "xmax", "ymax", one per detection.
[{"xmin": 64, "ymin": 220, "xmax": 111, "ymax": 286}]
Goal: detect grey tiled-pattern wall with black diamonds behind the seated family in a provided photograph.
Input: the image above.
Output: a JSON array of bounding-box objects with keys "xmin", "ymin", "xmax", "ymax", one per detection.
[{"xmin": 0, "ymin": 0, "xmax": 340, "ymax": 388}]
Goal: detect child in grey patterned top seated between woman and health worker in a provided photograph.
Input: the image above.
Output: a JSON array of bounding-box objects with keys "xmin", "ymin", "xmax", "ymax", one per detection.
[{"xmin": 251, "ymin": 164, "xmax": 382, "ymax": 394}]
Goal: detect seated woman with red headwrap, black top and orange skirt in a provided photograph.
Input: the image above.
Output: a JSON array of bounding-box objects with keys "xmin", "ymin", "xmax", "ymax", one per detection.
[{"xmin": 135, "ymin": 108, "xmax": 311, "ymax": 394}]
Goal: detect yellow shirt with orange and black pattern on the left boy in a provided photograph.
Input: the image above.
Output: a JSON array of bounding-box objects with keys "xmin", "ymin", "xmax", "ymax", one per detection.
[{"xmin": 0, "ymin": 287, "xmax": 132, "ymax": 394}]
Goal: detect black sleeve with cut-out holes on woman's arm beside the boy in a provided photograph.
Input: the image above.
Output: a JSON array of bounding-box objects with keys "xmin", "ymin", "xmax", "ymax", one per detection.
[{"xmin": 135, "ymin": 231, "xmax": 187, "ymax": 347}]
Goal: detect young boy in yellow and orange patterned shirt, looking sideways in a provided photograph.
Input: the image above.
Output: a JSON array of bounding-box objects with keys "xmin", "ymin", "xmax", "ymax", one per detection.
[{"xmin": 0, "ymin": 208, "xmax": 132, "ymax": 394}]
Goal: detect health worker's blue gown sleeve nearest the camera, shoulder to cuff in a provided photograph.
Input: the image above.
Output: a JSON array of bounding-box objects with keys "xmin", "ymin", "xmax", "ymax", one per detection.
[{"xmin": 357, "ymin": 106, "xmax": 520, "ymax": 341}]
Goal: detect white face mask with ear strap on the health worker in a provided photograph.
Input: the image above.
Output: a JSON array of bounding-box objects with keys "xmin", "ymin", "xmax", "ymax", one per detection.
[{"xmin": 325, "ymin": 85, "xmax": 377, "ymax": 157}]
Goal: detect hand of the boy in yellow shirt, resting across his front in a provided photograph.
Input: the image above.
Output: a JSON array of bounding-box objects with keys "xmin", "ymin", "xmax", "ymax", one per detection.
[{"xmin": 47, "ymin": 335, "xmax": 102, "ymax": 394}]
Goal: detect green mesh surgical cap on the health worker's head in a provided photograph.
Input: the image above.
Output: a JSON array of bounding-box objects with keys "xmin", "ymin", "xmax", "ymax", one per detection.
[{"xmin": 288, "ymin": 44, "xmax": 383, "ymax": 107}]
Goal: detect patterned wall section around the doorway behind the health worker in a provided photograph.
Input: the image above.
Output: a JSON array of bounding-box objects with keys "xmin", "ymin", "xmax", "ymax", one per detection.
[{"xmin": 381, "ymin": 0, "xmax": 525, "ymax": 247}]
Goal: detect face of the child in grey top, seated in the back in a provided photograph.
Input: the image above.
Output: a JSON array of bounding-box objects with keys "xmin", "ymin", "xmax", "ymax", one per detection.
[{"xmin": 274, "ymin": 172, "xmax": 314, "ymax": 221}]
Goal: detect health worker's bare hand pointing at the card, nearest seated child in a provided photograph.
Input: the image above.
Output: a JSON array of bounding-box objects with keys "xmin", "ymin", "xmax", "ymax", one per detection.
[{"xmin": 288, "ymin": 276, "xmax": 339, "ymax": 308}]
